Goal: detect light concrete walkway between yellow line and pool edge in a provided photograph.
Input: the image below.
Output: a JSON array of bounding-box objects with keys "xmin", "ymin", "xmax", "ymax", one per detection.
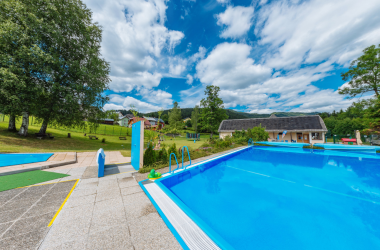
[{"xmin": 39, "ymin": 174, "xmax": 182, "ymax": 250}]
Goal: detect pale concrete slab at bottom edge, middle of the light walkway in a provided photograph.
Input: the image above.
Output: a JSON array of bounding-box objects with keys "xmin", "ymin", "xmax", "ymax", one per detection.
[{"xmin": 86, "ymin": 225, "xmax": 134, "ymax": 250}]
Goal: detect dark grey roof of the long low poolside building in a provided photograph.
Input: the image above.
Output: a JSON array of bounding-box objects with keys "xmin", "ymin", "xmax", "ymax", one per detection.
[{"xmin": 218, "ymin": 115, "xmax": 327, "ymax": 132}]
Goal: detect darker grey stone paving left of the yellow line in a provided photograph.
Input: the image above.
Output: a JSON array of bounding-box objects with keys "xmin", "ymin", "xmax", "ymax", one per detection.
[{"xmin": 0, "ymin": 181, "xmax": 75, "ymax": 250}]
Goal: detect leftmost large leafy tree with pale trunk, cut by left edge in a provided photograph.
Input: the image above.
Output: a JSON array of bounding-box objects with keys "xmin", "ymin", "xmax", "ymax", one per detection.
[{"xmin": 0, "ymin": 0, "xmax": 52, "ymax": 136}]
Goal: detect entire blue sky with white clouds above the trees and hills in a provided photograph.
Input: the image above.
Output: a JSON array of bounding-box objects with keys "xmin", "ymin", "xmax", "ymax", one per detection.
[{"xmin": 84, "ymin": 0, "xmax": 380, "ymax": 113}]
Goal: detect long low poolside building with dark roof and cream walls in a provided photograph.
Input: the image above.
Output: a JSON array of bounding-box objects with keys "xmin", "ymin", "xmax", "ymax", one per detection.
[{"xmin": 218, "ymin": 115, "xmax": 327, "ymax": 143}]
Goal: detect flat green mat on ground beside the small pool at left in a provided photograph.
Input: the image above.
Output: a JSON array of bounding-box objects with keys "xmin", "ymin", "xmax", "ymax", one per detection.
[{"xmin": 0, "ymin": 170, "xmax": 69, "ymax": 192}]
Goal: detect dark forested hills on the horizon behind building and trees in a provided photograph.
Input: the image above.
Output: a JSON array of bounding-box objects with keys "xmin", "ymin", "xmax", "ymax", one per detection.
[{"xmin": 136, "ymin": 108, "xmax": 319, "ymax": 119}]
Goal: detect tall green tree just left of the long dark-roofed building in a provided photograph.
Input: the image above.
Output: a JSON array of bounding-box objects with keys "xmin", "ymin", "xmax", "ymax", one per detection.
[{"xmin": 200, "ymin": 85, "xmax": 228, "ymax": 138}]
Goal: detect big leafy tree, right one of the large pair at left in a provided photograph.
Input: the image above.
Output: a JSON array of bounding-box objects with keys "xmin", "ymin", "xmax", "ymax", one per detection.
[{"xmin": 31, "ymin": 0, "xmax": 110, "ymax": 133}]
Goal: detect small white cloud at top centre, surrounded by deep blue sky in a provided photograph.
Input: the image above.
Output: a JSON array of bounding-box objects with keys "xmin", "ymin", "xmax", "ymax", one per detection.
[{"xmin": 217, "ymin": 6, "xmax": 254, "ymax": 38}]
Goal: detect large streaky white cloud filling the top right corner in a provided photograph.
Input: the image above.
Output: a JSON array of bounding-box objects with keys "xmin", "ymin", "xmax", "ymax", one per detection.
[{"xmin": 255, "ymin": 0, "xmax": 380, "ymax": 69}]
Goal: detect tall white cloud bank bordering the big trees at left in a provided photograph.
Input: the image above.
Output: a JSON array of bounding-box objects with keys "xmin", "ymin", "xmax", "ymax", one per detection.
[{"xmin": 84, "ymin": 0, "xmax": 184, "ymax": 92}]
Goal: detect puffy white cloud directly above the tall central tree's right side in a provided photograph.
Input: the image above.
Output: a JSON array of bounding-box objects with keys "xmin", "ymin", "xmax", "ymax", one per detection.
[{"xmin": 196, "ymin": 43, "xmax": 271, "ymax": 89}]
